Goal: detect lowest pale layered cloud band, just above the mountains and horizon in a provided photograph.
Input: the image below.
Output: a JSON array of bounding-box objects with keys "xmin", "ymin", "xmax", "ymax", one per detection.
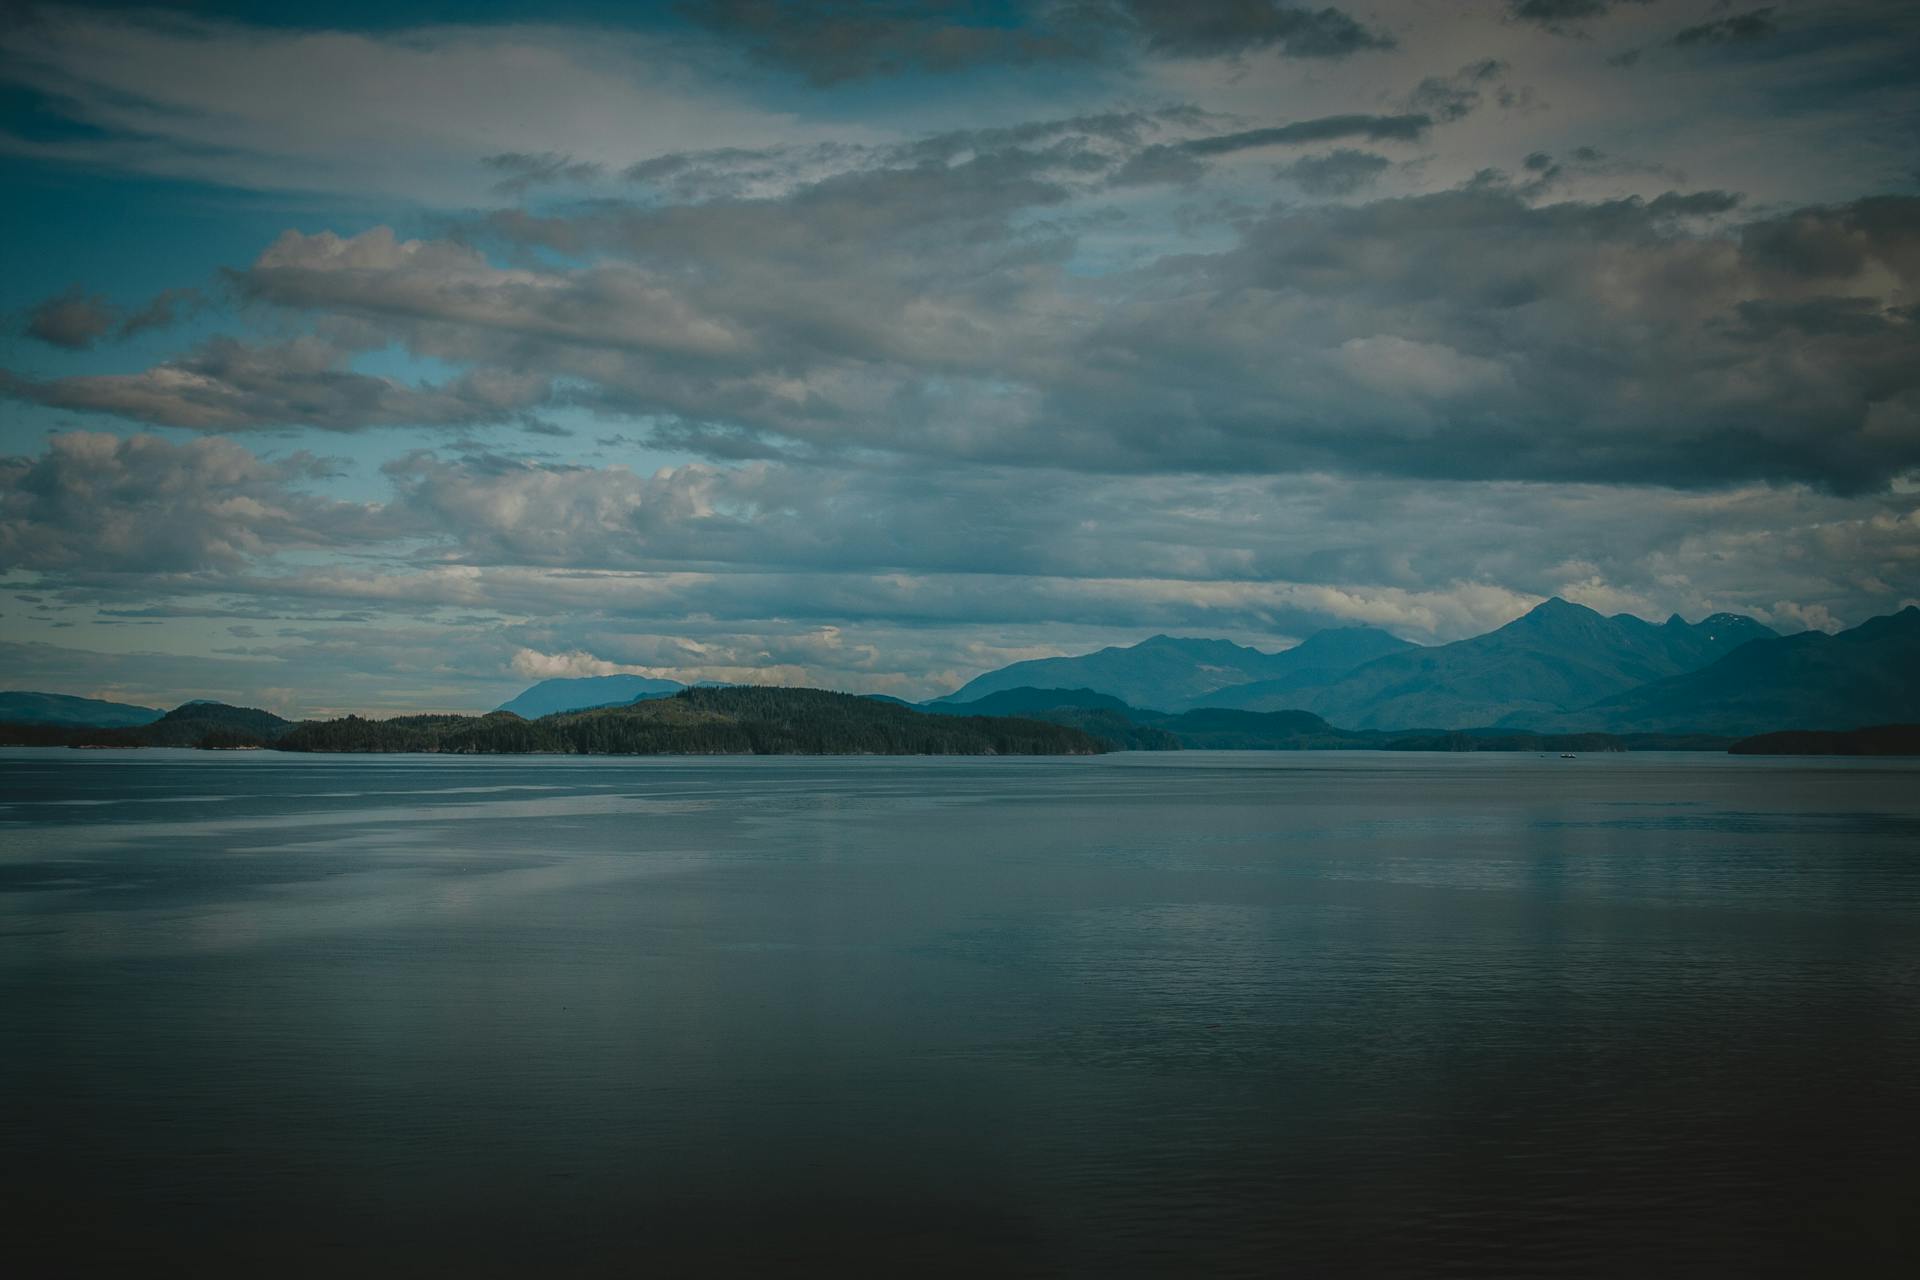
[{"xmin": 0, "ymin": 427, "xmax": 1920, "ymax": 710}]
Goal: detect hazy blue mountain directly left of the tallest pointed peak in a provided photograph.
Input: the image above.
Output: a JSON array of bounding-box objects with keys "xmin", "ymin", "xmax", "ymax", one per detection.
[{"xmin": 939, "ymin": 628, "xmax": 1411, "ymax": 712}]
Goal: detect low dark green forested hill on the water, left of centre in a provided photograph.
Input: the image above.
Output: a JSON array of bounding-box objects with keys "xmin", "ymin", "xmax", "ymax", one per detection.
[{"xmin": 276, "ymin": 687, "xmax": 1106, "ymax": 756}]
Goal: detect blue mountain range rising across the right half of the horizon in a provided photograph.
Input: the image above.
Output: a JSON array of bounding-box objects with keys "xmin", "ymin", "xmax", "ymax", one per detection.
[{"xmin": 945, "ymin": 597, "xmax": 1920, "ymax": 737}]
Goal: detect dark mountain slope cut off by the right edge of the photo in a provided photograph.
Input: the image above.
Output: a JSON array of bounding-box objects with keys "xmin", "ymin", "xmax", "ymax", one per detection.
[{"xmin": 1553, "ymin": 604, "xmax": 1920, "ymax": 737}]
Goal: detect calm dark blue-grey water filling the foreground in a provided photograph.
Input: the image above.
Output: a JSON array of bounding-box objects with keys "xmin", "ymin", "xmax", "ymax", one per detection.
[{"xmin": 0, "ymin": 750, "xmax": 1920, "ymax": 1276}]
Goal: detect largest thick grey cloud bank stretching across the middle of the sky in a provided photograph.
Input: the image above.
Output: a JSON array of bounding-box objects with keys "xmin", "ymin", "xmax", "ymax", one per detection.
[{"xmin": 22, "ymin": 148, "xmax": 1920, "ymax": 491}]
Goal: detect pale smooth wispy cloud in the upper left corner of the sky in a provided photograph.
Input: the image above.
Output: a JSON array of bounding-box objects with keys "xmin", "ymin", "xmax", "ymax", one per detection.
[{"xmin": 0, "ymin": 6, "xmax": 799, "ymax": 207}]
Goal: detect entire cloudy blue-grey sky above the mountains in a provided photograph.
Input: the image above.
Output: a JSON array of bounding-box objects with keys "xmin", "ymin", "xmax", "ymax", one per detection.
[{"xmin": 0, "ymin": 0, "xmax": 1920, "ymax": 716}]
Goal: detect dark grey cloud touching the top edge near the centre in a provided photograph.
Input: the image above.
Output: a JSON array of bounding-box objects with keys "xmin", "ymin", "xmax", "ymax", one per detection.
[{"xmin": 684, "ymin": 0, "xmax": 1394, "ymax": 86}]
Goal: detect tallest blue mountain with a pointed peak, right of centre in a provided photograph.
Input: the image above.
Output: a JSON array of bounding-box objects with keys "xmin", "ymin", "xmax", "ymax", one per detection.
[{"xmin": 1259, "ymin": 597, "xmax": 1774, "ymax": 729}]
